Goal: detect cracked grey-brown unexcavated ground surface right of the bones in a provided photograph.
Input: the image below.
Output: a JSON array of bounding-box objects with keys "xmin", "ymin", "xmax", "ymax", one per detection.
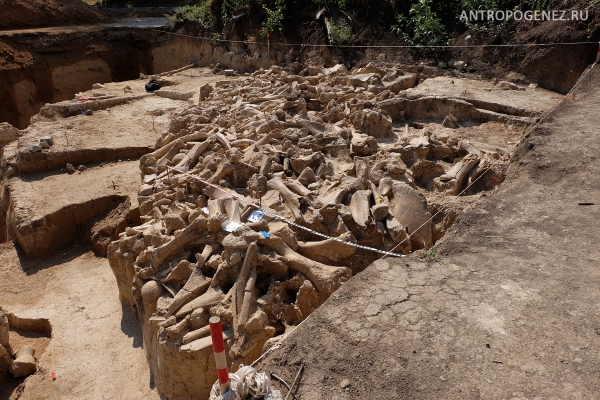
[{"xmin": 260, "ymin": 70, "xmax": 600, "ymax": 399}]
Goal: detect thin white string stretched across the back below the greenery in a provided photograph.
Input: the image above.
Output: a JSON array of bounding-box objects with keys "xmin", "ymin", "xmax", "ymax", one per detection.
[{"xmin": 148, "ymin": 28, "xmax": 598, "ymax": 49}]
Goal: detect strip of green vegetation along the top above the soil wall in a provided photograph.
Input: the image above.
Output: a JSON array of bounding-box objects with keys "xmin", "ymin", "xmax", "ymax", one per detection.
[{"xmin": 159, "ymin": 0, "xmax": 584, "ymax": 51}]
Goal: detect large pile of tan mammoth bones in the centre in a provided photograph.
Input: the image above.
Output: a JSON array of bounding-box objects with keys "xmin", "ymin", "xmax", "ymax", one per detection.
[{"xmin": 109, "ymin": 63, "xmax": 504, "ymax": 396}]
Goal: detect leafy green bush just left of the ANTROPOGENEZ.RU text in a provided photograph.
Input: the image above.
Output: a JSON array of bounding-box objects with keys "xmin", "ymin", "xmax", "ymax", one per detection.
[{"xmin": 392, "ymin": 0, "xmax": 448, "ymax": 46}]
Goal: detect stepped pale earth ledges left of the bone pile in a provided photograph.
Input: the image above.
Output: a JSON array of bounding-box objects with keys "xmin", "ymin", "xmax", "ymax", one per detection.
[{"xmin": 4, "ymin": 69, "xmax": 216, "ymax": 255}]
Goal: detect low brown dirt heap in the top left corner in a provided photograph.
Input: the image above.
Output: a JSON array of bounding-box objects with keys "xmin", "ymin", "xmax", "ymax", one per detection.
[{"xmin": 0, "ymin": 0, "xmax": 105, "ymax": 29}]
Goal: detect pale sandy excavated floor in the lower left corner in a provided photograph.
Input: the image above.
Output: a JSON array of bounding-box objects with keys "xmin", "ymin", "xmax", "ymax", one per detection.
[{"xmin": 0, "ymin": 243, "xmax": 158, "ymax": 399}]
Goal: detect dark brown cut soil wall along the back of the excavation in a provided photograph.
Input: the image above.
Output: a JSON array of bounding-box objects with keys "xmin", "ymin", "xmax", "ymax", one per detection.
[{"xmin": 0, "ymin": 18, "xmax": 595, "ymax": 129}]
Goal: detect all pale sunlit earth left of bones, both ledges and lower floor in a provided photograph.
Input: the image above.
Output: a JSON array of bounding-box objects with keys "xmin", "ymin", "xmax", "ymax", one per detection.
[{"xmin": 0, "ymin": 69, "xmax": 221, "ymax": 399}]
